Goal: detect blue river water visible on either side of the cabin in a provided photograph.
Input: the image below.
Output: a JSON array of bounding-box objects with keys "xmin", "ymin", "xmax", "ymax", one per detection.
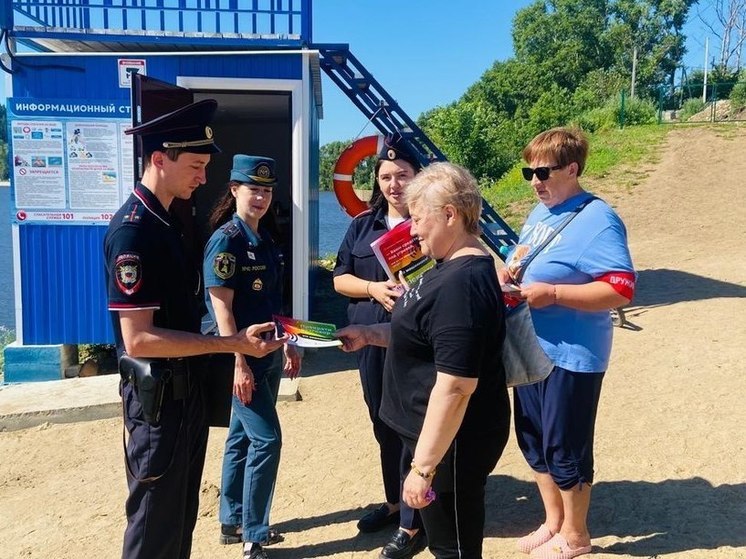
[{"xmin": 0, "ymin": 186, "xmax": 350, "ymax": 329}]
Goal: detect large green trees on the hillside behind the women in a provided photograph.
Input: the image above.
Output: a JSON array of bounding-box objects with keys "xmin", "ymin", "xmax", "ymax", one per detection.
[{"xmin": 419, "ymin": 0, "xmax": 696, "ymax": 183}]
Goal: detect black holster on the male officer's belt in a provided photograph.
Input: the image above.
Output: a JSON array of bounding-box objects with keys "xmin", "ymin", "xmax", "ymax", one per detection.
[{"xmin": 119, "ymin": 353, "xmax": 172, "ymax": 425}]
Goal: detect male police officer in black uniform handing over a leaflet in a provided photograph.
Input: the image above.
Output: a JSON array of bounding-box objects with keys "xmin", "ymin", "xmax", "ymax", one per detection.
[{"xmin": 104, "ymin": 99, "xmax": 285, "ymax": 559}]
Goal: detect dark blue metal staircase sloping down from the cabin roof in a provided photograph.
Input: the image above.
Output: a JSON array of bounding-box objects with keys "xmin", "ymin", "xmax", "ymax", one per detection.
[{"xmin": 312, "ymin": 44, "xmax": 518, "ymax": 257}]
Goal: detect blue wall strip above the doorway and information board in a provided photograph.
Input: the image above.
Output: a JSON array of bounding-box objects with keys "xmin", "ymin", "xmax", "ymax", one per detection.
[{"xmin": 13, "ymin": 54, "xmax": 302, "ymax": 101}]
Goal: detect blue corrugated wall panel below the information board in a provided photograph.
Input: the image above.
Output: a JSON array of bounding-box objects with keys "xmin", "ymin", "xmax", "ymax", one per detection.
[{"xmin": 18, "ymin": 224, "xmax": 114, "ymax": 345}]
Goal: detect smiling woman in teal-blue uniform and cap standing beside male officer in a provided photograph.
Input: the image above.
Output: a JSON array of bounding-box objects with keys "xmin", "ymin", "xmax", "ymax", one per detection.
[{"xmin": 203, "ymin": 154, "xmax": 300, "ymax": 559}]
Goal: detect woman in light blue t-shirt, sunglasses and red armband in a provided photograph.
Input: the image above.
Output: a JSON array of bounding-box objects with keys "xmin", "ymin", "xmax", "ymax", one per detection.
[{"xmin": 498, "ymin": 128, "xmax": 636, "ymax": 559}]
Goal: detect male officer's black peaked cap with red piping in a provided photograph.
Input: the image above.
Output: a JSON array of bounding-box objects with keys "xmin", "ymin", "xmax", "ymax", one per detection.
[{"xmin": 124, "ymin": 99, "xmax": 220, "ymax": 153}]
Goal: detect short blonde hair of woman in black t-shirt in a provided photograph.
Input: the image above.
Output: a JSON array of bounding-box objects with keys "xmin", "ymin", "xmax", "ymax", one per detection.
[{"xmin": 405, "ymin": 163, "xmax": 482, "ymax": 235}]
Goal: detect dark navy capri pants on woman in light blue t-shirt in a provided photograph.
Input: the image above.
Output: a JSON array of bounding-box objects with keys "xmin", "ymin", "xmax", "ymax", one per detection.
[{"xmin": 513, "ymin": 367, "xmax": 604, "ymax": 490}]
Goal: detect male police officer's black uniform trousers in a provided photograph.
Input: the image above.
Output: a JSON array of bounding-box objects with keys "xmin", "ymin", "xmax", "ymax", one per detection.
[{"xmin": 122, "ymin": 382, "xmax": 208, "ymax": 559}]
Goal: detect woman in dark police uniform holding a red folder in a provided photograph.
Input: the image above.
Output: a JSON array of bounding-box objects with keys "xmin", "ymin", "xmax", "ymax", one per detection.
[{"xmin": 334, "ymin": 135, "xmax": 424, "ymax": 559}]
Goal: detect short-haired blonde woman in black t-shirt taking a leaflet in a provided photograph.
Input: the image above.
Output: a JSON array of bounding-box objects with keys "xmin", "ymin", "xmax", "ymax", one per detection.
[{"xmin": 338, "ymin": 163, "xmax": 510, "ymax": 559}]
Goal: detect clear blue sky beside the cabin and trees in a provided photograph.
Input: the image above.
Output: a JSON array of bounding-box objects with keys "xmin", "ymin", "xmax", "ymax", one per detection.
[{"xmin": 313, "ymin": 0, "xmax": 713, "ymax": 144}]
